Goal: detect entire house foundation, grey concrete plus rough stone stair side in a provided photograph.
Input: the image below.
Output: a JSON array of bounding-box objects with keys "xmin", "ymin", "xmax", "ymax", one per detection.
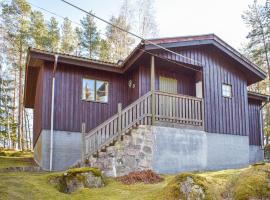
[{"xmin": 34, "ymin": 126, "xmax": 264, "ymax": 175}]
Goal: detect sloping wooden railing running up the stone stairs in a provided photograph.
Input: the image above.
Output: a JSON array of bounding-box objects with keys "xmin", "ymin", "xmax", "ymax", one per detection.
[{"xmin": 85, "ymin": 92, "xmax": 152, "ymax": 156}]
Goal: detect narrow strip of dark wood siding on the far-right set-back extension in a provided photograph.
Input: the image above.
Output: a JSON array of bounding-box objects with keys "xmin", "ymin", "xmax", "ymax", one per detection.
[{"xmin": 248, "ymin": 99, "xmax": 262, "ymax": 146}]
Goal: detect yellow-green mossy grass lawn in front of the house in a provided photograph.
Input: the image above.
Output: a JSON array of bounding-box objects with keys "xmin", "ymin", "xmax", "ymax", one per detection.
[{"xmin": 0, "ymin": 151, "xmax": 270, "ymax": 200}]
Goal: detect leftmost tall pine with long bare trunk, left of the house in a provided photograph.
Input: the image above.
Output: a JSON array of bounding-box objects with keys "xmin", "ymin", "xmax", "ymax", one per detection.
[{"xmin": 1, "ymin": 0, "xmax": 31, "ymax": 149}]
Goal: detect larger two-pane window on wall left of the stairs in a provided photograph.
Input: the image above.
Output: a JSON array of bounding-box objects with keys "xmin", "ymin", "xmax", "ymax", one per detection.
[{"xmin": 82, "ymin": 78, "xmax": 109, "ymax": 103}]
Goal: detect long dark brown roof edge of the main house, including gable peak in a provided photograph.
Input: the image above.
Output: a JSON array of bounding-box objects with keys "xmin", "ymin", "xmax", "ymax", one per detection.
[{"xmin": 28, "ymin": 34, "xmax": 266, "ymax": 80}]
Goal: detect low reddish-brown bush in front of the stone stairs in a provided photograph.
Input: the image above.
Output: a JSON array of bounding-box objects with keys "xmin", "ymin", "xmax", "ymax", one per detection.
[{"xmin": 118, "ymin": 170, "xmax": 163, "ymax": 185}]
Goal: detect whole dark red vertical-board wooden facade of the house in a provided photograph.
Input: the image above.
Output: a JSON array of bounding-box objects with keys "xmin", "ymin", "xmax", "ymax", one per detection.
[{"xmin": 24, "ymin": 34, "xmax": 266, "ymax": 145}]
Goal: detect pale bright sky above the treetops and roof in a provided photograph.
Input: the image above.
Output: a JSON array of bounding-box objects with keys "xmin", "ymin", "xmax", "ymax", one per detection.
[{"xmin": 25, "ymin": 0, "xmax": 260, "ymax": 49}]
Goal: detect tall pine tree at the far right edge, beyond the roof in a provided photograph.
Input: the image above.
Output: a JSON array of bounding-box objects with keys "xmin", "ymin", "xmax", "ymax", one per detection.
[{"xmin": 242, "ymin": 0, "xmax": 270, "ymax": 143}]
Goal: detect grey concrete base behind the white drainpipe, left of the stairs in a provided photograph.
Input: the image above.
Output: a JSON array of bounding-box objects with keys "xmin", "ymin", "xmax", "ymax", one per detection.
[{"xmin": 34, "ymin": 130, "xmax": 81, "ymax": 170}]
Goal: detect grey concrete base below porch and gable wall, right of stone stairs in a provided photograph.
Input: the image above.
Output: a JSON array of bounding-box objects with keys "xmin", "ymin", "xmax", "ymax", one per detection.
[{"xmin": 152, "ymin": 126, "xmax": 249, "ymax": 173}]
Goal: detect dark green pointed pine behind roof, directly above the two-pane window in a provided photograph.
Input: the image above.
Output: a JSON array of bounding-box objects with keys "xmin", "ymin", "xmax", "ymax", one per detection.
[{"xmin": 80, "ymin": 12, "xmax": 100, "ymax": 58}]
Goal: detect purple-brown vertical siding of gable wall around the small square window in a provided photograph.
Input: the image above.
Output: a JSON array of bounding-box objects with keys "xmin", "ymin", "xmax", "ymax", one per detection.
[{"xmin": 147, "ymin": 46, "xmax": 249, "ymax": 135}]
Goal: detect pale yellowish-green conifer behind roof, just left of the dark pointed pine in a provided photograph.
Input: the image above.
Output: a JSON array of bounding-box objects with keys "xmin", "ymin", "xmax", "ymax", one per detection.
[{"xmin": 61, "ymin": 18, "xmax": 77, "ymax": 54}]
